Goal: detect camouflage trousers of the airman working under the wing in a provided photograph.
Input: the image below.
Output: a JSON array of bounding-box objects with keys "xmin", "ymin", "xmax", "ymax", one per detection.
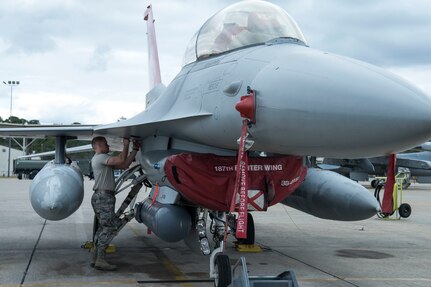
[{"xmin": 91, "ymin": 191, "xmax": 122, "ymax": 253}]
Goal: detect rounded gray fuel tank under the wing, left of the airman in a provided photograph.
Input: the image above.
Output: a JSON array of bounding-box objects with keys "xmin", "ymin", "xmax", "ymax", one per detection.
[{"xmin": 29, "ymin": 162, "xmax": 84, "ymax": 220}]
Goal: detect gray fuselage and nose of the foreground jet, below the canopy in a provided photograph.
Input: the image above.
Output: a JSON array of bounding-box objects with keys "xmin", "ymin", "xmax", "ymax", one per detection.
[{"xmin": 96, "ymin": 39, "xmax": 431, "ymax": 158}]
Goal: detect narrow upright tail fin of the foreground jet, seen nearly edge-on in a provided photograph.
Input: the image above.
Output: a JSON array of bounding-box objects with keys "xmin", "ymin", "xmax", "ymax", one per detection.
[{"xmin": 144, "ymin": 5, "xmax": 162, "ymax": 89}]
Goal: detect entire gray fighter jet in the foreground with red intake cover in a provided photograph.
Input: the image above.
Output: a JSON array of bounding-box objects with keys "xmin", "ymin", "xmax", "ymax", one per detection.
[{"xmin": 0, "ymin": 1, "xmax": 431, "ymax": 286}]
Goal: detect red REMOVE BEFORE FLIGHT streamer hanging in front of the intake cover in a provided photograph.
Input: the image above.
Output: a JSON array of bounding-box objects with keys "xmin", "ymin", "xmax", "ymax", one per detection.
[{"xmin": 230, "ymin": 120, "xmax": 248, "ymax": 238}]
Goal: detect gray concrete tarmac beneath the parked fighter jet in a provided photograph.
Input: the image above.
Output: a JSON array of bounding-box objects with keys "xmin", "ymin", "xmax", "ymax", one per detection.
[{"xmin": 0, "ymin": 178, "xmax": 431, "ymax": 287}]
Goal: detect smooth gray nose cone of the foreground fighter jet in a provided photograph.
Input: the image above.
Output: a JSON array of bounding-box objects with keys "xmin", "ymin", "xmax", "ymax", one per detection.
[{"xmin": 252, "ymin": 45, "xmax": 431, "ymax": 158}]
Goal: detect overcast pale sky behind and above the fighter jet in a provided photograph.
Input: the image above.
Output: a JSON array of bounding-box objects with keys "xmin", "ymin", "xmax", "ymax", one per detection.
[{"xmin": 0, "ymin": 0, "xmax": 431, "ymax": 124}]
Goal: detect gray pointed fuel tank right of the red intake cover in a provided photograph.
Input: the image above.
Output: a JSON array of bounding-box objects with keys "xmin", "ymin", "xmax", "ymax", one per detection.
[{"xmin": 282, "ymin": 168, "xmax": 380, "ymax": 221}]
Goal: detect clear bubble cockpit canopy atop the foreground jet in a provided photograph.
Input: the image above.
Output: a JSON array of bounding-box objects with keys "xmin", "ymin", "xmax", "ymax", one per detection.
[{"xmin": 184, "ymin": 0, "xmax": 305, "ymax": 65}]
